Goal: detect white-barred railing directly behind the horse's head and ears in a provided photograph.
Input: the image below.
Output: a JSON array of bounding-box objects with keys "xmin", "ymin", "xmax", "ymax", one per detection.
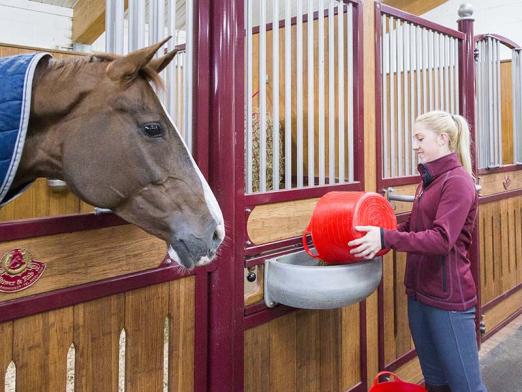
[{"xmin": 105, "ymin": 0, "xmax": 193, "ymax": 150}]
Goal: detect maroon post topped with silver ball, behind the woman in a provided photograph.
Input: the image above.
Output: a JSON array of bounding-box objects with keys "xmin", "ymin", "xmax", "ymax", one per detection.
[{"xmin": 458, "ymin": 4, "xmax": 481, "ymax": 345}]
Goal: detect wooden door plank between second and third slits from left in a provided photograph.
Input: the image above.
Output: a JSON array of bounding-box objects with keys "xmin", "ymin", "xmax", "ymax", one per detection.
[{"xmin": 74, "ymin": 294, "xmax": 125, "ymax": 392}]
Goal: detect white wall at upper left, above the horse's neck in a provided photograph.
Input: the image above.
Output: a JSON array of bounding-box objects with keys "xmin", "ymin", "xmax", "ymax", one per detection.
[{"xmin": 0, "ymin": 0, "xmax": 73, "ymax": 49}]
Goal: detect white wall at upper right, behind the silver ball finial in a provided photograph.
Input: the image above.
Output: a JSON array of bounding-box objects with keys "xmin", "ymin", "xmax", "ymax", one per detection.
[{"xmin": 422, "ymin": 0, "xmax": 522, "ymax": 59}]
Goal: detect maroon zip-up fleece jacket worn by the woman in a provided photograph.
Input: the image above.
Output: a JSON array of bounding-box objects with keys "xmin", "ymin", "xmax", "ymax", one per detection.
[{"xmin": 383, "ymin": 153, "xmax": 478, "ymax": 310}]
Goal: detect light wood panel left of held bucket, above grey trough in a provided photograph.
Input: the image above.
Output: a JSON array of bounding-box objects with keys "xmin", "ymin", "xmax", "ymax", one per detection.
[{"xmin": 247, "ymin": 199, "xmax": 319, "ymax": 244}]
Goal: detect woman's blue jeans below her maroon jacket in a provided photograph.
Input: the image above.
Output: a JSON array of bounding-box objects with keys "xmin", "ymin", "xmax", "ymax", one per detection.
[{"xmin": 408, "ymin": 298, "xmax": 487, "ymax": 392}]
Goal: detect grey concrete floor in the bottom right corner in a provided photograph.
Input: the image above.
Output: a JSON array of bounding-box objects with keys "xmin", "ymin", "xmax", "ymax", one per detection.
[{"xmin": 480, "ymin": 315, "xmax": 522, "ymax": 392}]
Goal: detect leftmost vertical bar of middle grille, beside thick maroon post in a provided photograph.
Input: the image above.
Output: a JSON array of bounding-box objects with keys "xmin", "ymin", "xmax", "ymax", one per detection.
[{"xmin": 245, "ymin": 0, "xmax": 254, "ymax": 193}]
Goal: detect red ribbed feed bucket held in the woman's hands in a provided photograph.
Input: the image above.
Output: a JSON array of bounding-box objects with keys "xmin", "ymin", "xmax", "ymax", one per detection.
[{"xmin": 303, "ymin": 192, "xmax": 397, "ymax": 264}]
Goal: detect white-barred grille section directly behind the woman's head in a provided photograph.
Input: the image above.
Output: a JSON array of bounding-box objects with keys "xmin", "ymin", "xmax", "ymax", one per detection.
[{"xmin": 381, "ymin": 14, "xmax": 459, "ymax": 178}]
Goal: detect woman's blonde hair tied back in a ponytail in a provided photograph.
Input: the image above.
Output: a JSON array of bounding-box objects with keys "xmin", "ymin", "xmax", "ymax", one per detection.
[{"xmin": 415, "ymin": 110, "xmax": 474, "ymax": 177}]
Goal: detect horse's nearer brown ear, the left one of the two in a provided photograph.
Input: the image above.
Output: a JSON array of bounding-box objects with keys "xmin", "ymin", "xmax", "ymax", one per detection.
[{"xmin": 106, "ymin": 37, "xmax": 171, "ymax": 81}]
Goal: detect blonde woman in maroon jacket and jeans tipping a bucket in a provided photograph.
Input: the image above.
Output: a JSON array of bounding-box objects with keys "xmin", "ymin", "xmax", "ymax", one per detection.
[{"xmin": 348, "ymin": 111, "xmax": 486, "ymax": 392}]
